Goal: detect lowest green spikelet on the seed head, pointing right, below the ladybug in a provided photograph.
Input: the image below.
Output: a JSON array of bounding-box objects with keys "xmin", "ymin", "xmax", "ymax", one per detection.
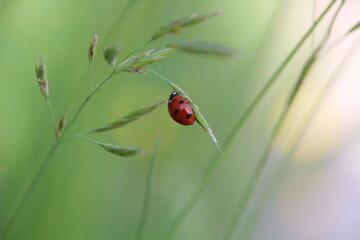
[{"xmin": 80, "ymin": 136, "xmax": 146, "ymax": 157}]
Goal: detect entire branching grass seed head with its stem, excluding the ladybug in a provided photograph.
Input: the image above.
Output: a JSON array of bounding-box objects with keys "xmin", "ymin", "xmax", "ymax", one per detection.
[{"xmin": 0, "ymin": 12, "xmax": 233, "ymax": 239}]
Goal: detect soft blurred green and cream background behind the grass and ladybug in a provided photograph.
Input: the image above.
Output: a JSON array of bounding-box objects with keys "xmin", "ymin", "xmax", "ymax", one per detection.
[{"xmin": 0, "ymin": 0, "xmax": 360, "ymax": 240}]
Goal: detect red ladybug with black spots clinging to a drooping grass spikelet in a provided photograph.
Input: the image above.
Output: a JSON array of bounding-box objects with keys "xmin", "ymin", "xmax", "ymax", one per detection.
[{"xmin": 168, "ymin": 91, "xmax": 195, "ymax": 125}]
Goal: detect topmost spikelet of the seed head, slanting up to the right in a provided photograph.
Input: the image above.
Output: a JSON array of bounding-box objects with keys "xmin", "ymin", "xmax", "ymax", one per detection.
[{"xmin": 150, "ymin": 11, "xmax": 222, "ymax": 42}]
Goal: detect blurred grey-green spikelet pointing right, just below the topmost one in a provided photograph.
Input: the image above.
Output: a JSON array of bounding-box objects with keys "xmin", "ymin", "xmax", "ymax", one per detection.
[{"xmin": 166, "ymin": 41, "xmax": 237, "ymax": 57}]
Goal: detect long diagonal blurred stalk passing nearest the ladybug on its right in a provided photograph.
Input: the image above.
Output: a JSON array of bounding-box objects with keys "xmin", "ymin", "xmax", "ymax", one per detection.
[{"xmin": 164, "ymin": 0, "xmax": 336, "ymax": 240}]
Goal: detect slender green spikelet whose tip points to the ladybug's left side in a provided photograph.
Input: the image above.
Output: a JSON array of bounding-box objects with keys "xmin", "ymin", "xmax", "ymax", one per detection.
[{"xmin": 86, "ymin": 101, "xmax": 166, "ymax": 133}]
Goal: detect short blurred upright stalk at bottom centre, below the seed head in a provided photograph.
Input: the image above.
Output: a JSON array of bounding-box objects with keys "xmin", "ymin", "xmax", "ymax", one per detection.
[{"xmin": 135, "ymin": 140, "xmax": 160, "ymax": 240}]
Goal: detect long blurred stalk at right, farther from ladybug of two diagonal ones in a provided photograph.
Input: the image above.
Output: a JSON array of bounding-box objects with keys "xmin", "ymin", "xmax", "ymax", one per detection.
[{"xmin": 223, "ymin": 1, "xmax": 345, "ymax": 240}]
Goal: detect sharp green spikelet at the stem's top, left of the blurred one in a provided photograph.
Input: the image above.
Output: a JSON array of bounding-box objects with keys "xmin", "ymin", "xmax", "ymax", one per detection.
[{"xmin": 116, "ymin": 48, "xmax": 176, "ymax": 73}]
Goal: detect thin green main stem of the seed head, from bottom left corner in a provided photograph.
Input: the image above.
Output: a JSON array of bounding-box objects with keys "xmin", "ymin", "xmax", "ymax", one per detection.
[{"xmin": 0, "ymin": 72, "xmax": 115, "ymax": 240}]
